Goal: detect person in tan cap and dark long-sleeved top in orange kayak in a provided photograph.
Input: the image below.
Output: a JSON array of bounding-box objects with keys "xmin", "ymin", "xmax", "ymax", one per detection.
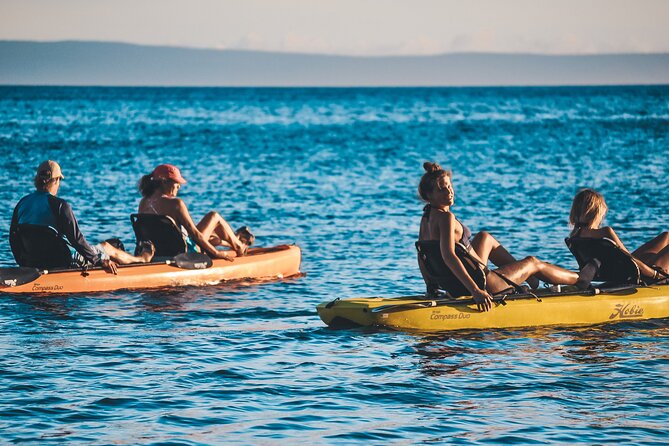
[{"xmin": 10, "ymin": 160, "xmax": 155, "ymax": 274}]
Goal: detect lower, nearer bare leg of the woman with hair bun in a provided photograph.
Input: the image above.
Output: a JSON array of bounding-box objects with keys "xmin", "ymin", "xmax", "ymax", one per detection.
[{"xmin": 487, "ymin": 256, "xmax": 578, "ymax": 294}]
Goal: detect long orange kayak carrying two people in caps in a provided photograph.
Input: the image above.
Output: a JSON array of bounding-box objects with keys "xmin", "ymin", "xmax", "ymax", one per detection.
[{"xmin": 0, "ymin": 245, "xmax": 302, "ymax": 294}]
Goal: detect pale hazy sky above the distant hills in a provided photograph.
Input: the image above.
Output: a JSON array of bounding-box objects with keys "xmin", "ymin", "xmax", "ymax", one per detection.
[{"xmin": 0, "ymin": 0, "xmax": 669, "ymax": 56}]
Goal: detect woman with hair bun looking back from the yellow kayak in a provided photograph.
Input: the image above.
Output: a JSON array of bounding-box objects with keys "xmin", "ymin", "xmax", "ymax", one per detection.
[{"xmin": 418, "ymin": 162, "xmax": 578, "ymax": 311}]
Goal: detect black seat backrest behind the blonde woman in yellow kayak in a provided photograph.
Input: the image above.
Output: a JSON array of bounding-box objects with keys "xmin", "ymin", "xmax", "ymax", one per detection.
[{"xmin": 565, "ymin": 237, "xmax": 641, "ymax": 285}]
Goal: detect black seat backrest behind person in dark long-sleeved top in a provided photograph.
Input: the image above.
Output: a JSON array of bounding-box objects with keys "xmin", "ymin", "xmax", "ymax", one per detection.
[{"xmin": 9, "ymin": 224, "xmax": 72, "ymax": 269}]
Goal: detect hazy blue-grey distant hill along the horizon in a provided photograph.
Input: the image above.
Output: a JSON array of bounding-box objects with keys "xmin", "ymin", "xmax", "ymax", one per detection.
[{"xmin": 0, "ymin": 41, "xmax": 669, "ymax": 86}]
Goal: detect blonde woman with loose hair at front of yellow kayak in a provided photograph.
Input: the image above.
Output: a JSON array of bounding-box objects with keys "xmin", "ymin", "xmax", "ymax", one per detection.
[{"xmin": 569, "ymin": 189, "xmax": 669, "ymax": 279}]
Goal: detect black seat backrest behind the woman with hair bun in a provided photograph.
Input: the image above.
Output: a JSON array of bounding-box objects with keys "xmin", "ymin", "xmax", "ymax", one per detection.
[{"xmin": 416, "ymin": 240, "xmax": 486, "ymax": 297}]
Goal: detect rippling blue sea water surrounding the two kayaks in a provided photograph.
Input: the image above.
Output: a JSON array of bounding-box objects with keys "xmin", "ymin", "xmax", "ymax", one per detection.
[{"xmin": 0, "ymin": 87, "xmax": 669, "ymax": 444}]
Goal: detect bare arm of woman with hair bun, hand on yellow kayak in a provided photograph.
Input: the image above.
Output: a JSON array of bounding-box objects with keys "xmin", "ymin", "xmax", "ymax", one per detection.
[{"xmin": 437, "ymin": 212, "xmax": 492, "ymax": 311}]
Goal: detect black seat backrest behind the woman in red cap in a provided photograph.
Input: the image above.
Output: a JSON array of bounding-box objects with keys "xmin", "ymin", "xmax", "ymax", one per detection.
[{"xmin": 130, "ymin": 214, "xmax": 187, "ymax": 257}]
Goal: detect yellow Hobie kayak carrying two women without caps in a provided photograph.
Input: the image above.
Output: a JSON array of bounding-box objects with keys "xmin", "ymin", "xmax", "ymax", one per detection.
[{"xmin": 317, "ymin": 285, "xmax": 669, "ymax": 331}]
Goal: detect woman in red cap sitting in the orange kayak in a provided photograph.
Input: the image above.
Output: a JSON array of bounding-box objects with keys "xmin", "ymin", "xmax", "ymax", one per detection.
[{"xmin": 138, "ymin": 164, "xmax": 255, "ymax": 260}]
